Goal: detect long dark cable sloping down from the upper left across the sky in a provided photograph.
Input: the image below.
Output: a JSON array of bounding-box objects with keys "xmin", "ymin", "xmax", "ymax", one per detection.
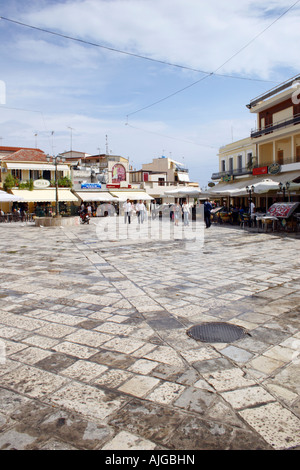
[{"xmin": 0, "ymin": 14, "xmax": 276, "ymax": 83}]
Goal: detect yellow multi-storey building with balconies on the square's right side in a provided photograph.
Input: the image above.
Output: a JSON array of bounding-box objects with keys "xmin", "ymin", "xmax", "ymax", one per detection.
[{"xmin": 211, "ymin": 77, "xmax": 300, "ymax": 209}]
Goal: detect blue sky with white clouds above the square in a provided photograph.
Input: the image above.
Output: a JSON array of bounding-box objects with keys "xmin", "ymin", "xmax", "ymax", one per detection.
[{"xmin": 0, "ymin": 0, "xmax": 300, "ymax": 187}]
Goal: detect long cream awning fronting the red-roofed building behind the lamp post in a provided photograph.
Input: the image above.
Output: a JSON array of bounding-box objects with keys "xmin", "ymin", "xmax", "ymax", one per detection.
[{"xmin": 12, "ymin": 188, "xmax": 78, "ymax": 202}]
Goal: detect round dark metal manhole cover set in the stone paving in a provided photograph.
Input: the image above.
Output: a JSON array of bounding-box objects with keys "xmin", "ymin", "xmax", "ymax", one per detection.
[{"xmin": 187, "ymin": 322, "xmax": 247, "ymax": 343}]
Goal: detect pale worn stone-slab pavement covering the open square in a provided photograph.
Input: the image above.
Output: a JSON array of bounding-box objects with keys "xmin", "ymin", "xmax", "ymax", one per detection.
[{"xmin": 0, "ymin": 219, "xmax": 300, "ymax": 450}]
